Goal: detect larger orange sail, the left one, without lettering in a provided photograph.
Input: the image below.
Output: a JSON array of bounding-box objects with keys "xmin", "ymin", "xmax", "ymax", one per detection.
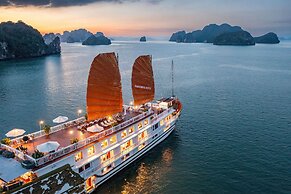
[{"xmin": 87, "ymin": 53, "xmax": 123, "ymax": 121}]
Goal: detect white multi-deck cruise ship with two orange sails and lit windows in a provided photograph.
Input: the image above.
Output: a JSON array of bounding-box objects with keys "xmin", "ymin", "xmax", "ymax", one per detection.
[{"xmin": 0, "ymin": 53, "xmax": 182, "ymax": 193}]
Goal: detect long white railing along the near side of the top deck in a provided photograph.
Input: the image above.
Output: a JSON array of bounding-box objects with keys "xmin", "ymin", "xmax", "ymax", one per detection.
[{"xmin": 35, "ymin": 110, "xmax": 153, "ymax": 166}]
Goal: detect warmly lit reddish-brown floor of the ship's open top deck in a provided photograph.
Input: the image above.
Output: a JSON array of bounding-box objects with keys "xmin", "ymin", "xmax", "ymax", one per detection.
[{"xmin": 12, "ymin": 111, "xmax": 141, "ymax": 156}]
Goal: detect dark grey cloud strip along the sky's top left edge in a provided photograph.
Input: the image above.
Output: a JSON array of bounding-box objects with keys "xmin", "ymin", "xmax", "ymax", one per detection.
[{"xmin": 0, "ymin": 0, "xmax": 162, "ymax": 7}]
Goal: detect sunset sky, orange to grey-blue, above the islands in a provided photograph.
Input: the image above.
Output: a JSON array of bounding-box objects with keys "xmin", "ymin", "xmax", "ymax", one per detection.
[{"xmin": 0, "ymin": 0, "xmax": 291, "ymax": 36}]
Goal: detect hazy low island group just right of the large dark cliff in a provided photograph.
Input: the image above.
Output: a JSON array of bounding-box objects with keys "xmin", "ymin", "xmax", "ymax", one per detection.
[{"xmin": 43, "ymin": 29, "xmax": 111, "ymax": 45}]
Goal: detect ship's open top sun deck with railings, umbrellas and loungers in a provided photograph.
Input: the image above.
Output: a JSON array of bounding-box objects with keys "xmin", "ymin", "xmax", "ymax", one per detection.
[{"xmin": 1, "ymin": 100, "xmax": 176, "ymax": 173}]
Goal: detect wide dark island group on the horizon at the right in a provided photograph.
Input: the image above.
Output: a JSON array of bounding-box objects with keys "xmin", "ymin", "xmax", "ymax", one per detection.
[{"xmin": 169, "ymin": 24, "xmax": 280, "ymax": 46}]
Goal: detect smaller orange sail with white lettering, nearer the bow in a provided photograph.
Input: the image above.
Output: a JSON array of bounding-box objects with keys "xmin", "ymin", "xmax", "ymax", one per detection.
[{"xmin": 131, "ymin": 55, "xmax": 155, "ymax": 105}]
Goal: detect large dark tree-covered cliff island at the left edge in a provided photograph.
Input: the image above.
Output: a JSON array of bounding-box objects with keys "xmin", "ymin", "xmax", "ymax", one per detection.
[{"xmin": 0, "ymin": 21, "xmax": 61, "ymax": 60}]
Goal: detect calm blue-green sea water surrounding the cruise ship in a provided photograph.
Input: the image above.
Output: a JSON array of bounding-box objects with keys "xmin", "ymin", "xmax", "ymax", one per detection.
[{"xmin": 0, "ymin": 42, "xmax": 291, "ymax": 193}]
